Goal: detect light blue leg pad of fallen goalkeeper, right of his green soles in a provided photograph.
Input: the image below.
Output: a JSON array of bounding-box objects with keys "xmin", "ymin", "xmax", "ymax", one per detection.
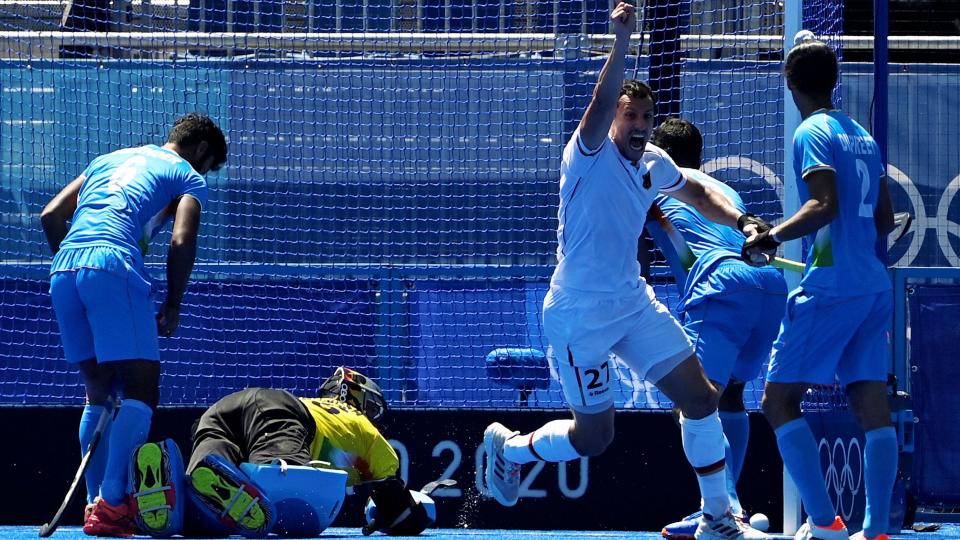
[{"xmin": 240, "ymin": 462, "xmax": 347, "ymax": 537}]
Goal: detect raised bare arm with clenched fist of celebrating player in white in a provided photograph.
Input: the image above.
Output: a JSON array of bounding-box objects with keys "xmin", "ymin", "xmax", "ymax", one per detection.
[{"xmin": 580, "ymin": 2, "xmax": 637, "ymax": 150}]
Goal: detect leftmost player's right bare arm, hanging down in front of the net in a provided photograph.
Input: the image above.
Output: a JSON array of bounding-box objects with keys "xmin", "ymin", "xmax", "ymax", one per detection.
[{"xmin": 157, "ymin": 197, "xmax": 200, "ymax": 336}]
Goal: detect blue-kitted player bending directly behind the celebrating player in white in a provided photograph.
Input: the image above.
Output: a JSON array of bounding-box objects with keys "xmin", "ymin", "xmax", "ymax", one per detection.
[{"xmin": 651, "ymin": 118, "xmax": 787, "ymax": 539}]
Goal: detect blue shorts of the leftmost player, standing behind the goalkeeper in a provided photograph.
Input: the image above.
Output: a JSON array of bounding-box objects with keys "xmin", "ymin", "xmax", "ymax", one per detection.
[{"xmin": 50, "ymin": 249, "xmax": 160, "ymax": 363}]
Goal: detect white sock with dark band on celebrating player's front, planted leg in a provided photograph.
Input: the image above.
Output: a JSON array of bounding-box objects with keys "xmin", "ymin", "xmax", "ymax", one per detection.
[{"xmin": 680, "ymin": 411, "xmax": 730, "ymax": 518}]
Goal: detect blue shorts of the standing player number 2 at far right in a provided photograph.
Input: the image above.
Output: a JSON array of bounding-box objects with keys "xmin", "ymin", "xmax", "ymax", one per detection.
[{"xmin": 767, "ymin": 289, "xmax": 893, "ymax": 386}]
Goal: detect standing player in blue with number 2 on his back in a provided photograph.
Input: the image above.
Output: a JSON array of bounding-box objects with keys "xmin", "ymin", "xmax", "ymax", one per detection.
[{"xmin": 745, "ymin": 40, "xmax": 897, "ymax": 540}]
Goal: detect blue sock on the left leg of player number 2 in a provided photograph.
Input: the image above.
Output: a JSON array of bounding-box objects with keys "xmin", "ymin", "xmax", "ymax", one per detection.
[{"xmin": 774, "ymin": 418, "xmax": 836, "ymax": 527}]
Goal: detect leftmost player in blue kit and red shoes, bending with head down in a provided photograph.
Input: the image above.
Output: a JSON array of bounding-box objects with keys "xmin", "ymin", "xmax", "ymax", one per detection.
[{"xmin": 41, "ymin": 114, "xmax": 227, "ymax": 536}]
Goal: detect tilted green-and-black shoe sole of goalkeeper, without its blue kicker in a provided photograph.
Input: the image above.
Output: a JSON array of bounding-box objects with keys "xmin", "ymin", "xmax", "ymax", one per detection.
[{"xmin": 190, "ymin": 466, "xmax": 268, "ymax": 533}]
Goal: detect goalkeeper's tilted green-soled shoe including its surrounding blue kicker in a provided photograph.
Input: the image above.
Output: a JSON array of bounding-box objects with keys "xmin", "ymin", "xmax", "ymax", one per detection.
[{"xmin": 190, "ymin": 454, "xmax": 277, "ymax": 538}]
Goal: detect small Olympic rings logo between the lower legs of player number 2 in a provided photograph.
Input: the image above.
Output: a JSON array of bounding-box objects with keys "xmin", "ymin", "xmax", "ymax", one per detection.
[{"xmin": 817, "ymin": 437, "xmax": 863, "ymax": 520}]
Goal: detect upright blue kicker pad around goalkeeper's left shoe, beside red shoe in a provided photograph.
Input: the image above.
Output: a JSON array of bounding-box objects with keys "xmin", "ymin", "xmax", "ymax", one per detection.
[{"xmin": 128, "ymin": 439, "xmax": 186, "ymax": 538}]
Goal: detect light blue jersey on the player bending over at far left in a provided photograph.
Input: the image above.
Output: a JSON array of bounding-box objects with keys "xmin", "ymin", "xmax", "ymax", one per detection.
[{"xmin": 51, "ymin": 145, "xmax": 207, "ymax": 273}]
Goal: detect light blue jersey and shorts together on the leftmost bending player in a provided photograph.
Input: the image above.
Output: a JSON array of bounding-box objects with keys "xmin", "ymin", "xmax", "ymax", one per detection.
[{"xmin": 50, "ymin": 145, "xmax": 207, "ymax": 363}]
